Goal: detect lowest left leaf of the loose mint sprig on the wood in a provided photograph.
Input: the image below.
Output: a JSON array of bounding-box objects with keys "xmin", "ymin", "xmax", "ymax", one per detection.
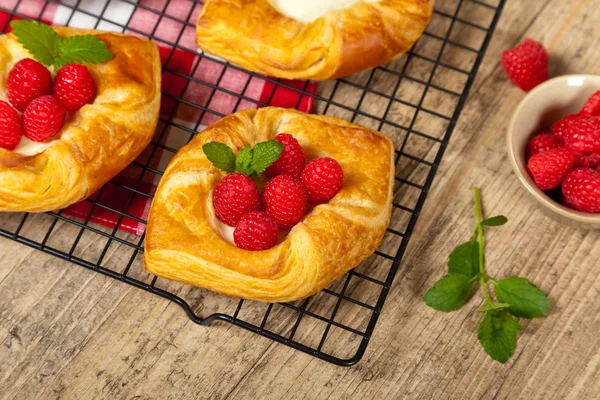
[{"xmin": 423, "ymin": 274, "xmax": 473, "ymax": 312}]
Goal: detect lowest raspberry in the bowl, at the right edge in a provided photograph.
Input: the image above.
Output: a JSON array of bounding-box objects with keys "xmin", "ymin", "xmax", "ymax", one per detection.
[{"xmin": 562, "ymin": 168, "xmax": 600, "ymax": 212}]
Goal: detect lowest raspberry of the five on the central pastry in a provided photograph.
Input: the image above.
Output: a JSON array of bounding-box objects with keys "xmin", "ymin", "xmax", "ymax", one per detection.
[{"xmin": 233, "ymin": 211, "xmax": 279, "ymax": 251}]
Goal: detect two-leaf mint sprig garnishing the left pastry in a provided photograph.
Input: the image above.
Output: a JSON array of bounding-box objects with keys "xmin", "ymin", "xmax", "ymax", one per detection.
[{"xmin": 10, "ymin": 21, "xmax": 113, "ymax": 68}]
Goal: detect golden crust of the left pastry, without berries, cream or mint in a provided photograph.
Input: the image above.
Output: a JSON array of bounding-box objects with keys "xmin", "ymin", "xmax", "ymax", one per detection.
[{"xmin": 0, "ymin": 27, "xmax": 161, "ymax": 212}]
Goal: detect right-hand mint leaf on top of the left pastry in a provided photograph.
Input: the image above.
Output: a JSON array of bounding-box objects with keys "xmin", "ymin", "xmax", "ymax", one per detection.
[{"xmin": 54, "ymin": 35, "xmax": 113, "ymax": 67}]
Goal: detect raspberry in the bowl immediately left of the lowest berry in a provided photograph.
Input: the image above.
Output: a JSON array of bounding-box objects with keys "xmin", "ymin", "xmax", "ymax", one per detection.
[{"xmin": 527, "ymin": 148, "xmax": 577, "ymax": 190}]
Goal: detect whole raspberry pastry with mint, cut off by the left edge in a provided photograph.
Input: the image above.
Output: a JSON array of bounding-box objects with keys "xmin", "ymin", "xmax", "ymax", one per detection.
[{"xmin": 0, "ymin": 21, "xmax": 161, "ymax": 212}]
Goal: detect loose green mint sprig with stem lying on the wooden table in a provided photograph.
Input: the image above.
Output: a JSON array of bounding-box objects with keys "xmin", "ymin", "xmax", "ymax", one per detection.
[{"xmin": 424, "ymin": 188, "xmax": 550, "ymax": 363}]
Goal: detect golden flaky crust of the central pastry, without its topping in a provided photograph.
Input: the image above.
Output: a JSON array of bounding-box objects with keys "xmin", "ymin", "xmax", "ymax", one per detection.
[{"xmin": 144, "ymin": 107, "xmax": 394, "ymax": 302}]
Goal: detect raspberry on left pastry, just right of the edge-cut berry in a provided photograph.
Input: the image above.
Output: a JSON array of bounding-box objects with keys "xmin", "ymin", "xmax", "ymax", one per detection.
[{"xmin": 23, "ymin": 95, "xmax": 65, "ymax": 142}]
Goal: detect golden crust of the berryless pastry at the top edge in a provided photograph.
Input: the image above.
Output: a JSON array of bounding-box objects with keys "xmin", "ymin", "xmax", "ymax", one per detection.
[{"xmin": 196, "ymin": 0, "xmax": 435, "ymax": 80}]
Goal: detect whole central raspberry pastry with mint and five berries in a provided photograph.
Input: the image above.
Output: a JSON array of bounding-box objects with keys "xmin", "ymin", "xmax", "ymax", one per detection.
[{"xmin": 144, "ymin": 107, "xmax": 394, "ymax": 302}]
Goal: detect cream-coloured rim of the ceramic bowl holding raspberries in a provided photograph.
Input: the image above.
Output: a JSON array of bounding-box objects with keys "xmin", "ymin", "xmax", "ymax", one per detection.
[{"xmin": 506, "ymin": 74, "xmax": 600, "ymax": 225}]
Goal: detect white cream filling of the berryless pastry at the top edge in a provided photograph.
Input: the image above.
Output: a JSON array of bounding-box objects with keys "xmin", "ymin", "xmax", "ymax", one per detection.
[{"xmin": 269, "ymin": 0, "xmax": 380, "ymax": 22}]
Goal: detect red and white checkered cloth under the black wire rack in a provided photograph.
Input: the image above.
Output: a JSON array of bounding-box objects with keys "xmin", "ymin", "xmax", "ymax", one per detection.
[{"xmin": 0, "ymin": 0, "xmax": 317, "ymax": 235}]
